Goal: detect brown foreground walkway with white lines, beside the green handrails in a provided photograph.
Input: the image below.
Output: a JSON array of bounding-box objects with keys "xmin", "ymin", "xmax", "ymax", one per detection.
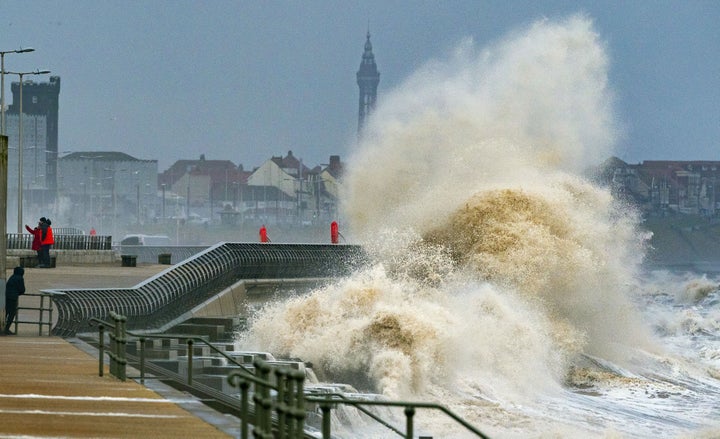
[{"xmin": 0, "ymin": 336, "xmax": 232, "ymax": 439}]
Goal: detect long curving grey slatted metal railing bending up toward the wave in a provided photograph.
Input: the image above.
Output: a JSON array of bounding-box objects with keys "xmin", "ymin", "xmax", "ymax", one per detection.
[{"xmin": 44, "ymin": 243, "xmax": 366, "ymax": 337}]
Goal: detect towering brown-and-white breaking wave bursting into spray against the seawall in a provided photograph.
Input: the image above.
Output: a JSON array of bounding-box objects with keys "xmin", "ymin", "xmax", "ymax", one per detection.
[{"xmin": 232, "ymin": 16, "xmax": 710, "ymax": 439}]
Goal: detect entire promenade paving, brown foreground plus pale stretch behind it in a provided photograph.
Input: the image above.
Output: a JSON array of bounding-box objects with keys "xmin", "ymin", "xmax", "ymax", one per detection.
[{"xmin": 0, "ymin": 264, "xmax": 239, "ymax": 439}]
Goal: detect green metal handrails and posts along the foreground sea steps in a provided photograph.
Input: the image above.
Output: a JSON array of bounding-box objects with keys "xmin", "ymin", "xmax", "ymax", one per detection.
[{"xmin": 92, "ymin": 311, "xmax": 488, "ymax": 439}]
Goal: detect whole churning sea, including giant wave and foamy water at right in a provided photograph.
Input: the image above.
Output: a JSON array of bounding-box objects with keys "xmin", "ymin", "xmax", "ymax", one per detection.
[{"xmin": 238, "ymin": 15, "xmax": 720, "ymax": 438}]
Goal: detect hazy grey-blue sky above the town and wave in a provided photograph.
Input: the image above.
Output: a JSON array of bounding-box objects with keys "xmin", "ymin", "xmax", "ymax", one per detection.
[{"xmin": 0, "ymin": 0, "xmax": 720, "ymax": 171}]
